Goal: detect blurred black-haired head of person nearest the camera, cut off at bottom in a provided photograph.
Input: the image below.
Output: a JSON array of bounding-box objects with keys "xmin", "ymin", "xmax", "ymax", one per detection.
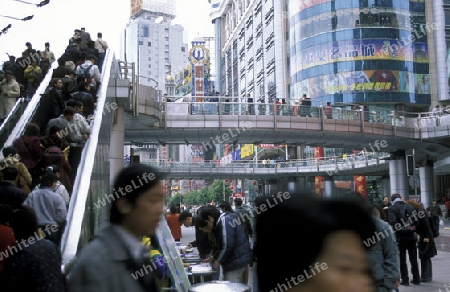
[{"xmin": 255, "ymin": 194, "xmax": 376, "ymax": 292}]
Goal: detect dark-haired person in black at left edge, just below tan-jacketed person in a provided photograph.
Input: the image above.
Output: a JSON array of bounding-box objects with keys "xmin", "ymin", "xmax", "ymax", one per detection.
[{"xmin": 0, "ymin": 166, "xmax": 27, "ymax": 209}]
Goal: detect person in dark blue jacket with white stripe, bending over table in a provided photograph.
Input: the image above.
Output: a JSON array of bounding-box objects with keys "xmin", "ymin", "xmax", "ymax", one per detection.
[{"xmin": 197, "ymin": 206, "xmax": 253, "ymax": 284}]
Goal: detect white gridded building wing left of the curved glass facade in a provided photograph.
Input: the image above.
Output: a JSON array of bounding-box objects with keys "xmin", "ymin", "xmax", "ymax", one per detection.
[{"xmin": 209, "ymin": 0, "xmax": 288, "ymax": 103}]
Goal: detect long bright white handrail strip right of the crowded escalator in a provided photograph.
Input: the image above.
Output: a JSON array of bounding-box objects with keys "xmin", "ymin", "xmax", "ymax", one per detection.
[{"xmin": 61, "ymin": 49, "xmax": 115, "ymax": 274}]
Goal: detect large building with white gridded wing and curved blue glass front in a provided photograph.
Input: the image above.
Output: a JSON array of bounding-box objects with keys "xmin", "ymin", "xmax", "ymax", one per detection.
[{"xmin": 209, "ymin": 0, "xmax": 450, "ymax": 111}]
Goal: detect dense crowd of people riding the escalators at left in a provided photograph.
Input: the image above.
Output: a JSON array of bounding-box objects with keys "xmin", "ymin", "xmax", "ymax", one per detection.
[{"xmin": 0, "ymin": 28, "xmax": 108, "ymax": 292}]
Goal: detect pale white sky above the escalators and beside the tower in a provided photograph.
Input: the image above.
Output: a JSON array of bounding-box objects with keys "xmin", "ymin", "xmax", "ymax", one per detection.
[{"xmin": 0, "ymin": 0, "xmax": 214, "ymax": 64}]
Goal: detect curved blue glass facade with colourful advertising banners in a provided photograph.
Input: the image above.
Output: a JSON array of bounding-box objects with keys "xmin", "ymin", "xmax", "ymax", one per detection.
[{"xmin": 288, "ymin": 0, "xmax": 433, "ymax": 106}]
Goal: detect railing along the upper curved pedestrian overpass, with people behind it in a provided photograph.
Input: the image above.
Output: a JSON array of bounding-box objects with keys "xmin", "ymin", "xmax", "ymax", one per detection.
[{"xmin": 163, "ymin": 96, "xmax": 450, "ymax": 129}]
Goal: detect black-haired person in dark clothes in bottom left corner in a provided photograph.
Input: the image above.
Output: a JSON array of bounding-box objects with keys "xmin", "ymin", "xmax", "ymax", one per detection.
[{"xmin": 0, "ymin": 205, "xmax": 65, "ymax": 292}]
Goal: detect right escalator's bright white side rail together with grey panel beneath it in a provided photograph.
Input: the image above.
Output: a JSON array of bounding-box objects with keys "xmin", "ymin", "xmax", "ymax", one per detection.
[{"xmin": 61, "ymin": 50, "xmax": 116, "ymax": 275}]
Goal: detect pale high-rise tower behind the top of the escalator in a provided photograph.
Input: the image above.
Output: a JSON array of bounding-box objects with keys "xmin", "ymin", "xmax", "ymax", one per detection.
[{"xmin": 121, "ymin": 0, "xmax": 189, "ymax": 91}]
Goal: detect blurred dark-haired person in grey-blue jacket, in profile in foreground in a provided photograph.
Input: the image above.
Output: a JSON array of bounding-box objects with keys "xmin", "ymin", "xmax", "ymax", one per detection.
[{"xmin": 68, "ymin": 164, "xmax": 165, "ymax": 292}]
